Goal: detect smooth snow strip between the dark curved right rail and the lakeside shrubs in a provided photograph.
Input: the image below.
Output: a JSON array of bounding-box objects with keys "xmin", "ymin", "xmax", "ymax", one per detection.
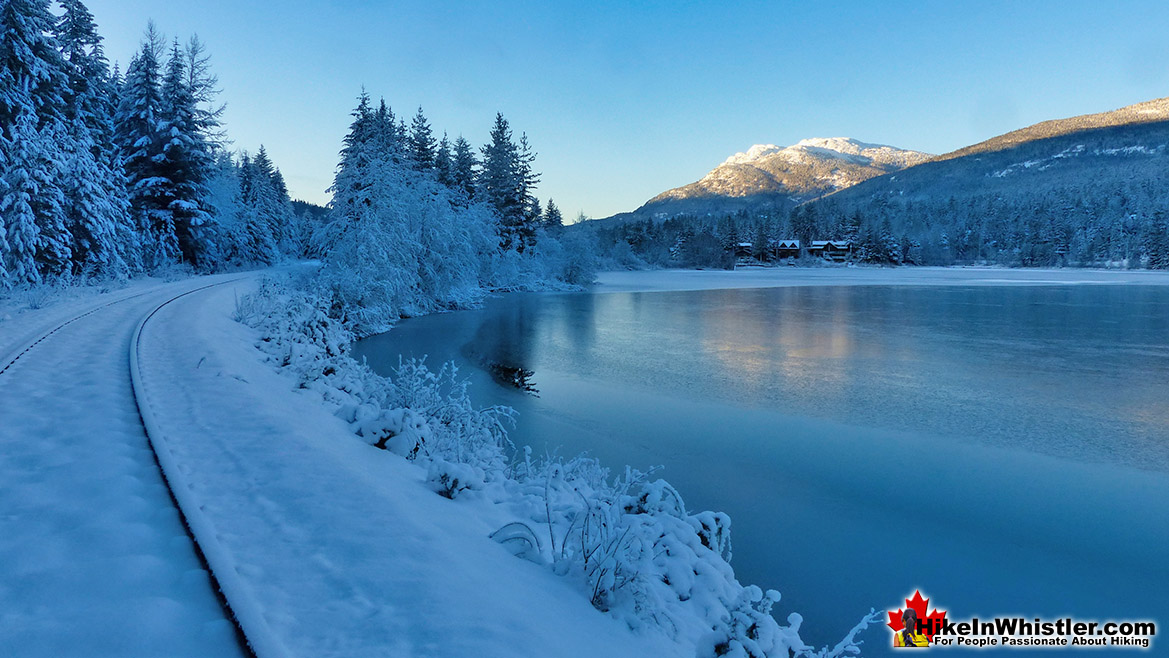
[{"xmin": 132, "ymin": 279, "xmax": 679, "ymax": 657}]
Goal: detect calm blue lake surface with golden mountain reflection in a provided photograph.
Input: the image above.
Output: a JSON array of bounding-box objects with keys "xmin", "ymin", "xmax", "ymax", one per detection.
[{"xmin": 355, "ymin": 285, "xmax": 1169, "ymax": 656}]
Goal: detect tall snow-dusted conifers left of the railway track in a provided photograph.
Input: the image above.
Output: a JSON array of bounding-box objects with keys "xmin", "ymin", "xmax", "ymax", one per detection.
[{"xmin": 0, "ymin": 0, "xmax": 307, "ymax": 288}]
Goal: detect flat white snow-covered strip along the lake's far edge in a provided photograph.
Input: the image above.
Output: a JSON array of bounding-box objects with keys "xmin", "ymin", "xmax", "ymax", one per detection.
[{"xmin": 592, "ymin": 268, "xmax": 1169, "ymax": 292}]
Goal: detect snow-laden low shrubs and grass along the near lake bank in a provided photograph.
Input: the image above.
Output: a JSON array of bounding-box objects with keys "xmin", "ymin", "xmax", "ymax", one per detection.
[{"xmin": 235, "ymin": 275, "xmax": 878, "ymax": 657}]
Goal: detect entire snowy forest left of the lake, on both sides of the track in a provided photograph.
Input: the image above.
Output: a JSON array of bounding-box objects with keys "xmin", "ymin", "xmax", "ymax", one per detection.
[{"xmin": 0, "ymin": 0, "xmax": 584, "ymax": 299}]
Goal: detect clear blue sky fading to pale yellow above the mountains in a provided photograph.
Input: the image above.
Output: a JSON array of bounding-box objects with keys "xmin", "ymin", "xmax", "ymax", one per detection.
[{"xmin": 88, "ymin": 0, "xmax": 1169, "ymax": 220}]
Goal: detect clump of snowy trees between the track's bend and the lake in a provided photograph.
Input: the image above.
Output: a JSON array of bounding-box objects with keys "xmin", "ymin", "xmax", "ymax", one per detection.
[{"xmin": 310, "ymin": 91, "xmax": 595, "ymax": 333}]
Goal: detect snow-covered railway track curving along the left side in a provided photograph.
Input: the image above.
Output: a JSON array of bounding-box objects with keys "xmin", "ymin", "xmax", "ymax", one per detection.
[{"xmin": 0, "ymin": 277, "xmax": 254, "ymax": 656}]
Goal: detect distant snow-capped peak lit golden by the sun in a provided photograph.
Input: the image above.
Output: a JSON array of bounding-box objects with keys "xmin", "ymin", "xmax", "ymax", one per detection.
[{"xmin": 617, "ymin": 137, "xmax": 932, "ymax": 219}]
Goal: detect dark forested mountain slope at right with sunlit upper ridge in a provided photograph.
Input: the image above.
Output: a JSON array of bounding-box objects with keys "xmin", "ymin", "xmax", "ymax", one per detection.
[{"xmin": 807, "ymin": 98, "xmax": 1169, "ymax": 269}]
